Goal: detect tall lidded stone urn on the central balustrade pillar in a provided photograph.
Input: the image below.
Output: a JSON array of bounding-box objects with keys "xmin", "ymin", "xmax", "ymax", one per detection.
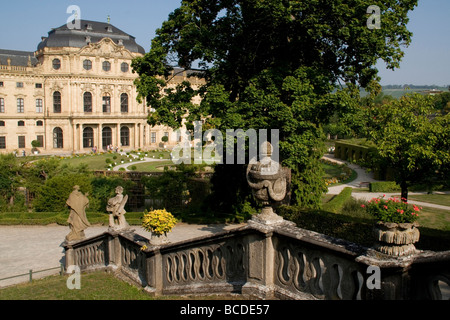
[{"xmin": 246, "ymin": 142, "xmax": 290, "ymax": 224}]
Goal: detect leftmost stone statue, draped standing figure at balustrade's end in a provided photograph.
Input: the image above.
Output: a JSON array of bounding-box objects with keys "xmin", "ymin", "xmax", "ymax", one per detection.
[{"xmin": 66, "ymin": 186, "xmax": 91, "ymax": 241}]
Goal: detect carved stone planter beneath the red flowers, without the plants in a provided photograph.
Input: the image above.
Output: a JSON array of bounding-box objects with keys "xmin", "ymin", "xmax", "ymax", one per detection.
[{"xmin": 374, "ymin": 221, "xmax": 420, "ymax": 257}]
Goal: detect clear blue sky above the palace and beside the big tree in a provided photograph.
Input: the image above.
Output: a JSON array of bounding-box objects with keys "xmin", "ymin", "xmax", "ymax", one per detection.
[{"xmin": 0, "ymin": 0, "xmax": 450, "ymax": 86}]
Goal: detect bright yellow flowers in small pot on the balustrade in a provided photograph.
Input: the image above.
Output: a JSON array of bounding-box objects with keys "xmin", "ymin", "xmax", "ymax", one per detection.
[{"xmin": 142, "ymin": 209, "xmax": 177, "ymax": 244}]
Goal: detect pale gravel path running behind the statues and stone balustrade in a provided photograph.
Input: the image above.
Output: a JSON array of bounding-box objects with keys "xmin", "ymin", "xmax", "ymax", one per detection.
[{"xmin": 0, "ymin": 223, "xmax": 242, "ymax": 288}]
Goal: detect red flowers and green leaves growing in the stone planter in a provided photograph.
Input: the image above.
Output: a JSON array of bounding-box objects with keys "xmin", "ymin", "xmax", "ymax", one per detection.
[{"xmin": 361, "ymin": 195, "xmax": 422, "ymax": 223}]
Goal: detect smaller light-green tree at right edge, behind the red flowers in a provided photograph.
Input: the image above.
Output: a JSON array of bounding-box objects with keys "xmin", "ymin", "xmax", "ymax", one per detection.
[{"xmin": 367, "ymin": 93, "xmax": 450, "ymax": 201}]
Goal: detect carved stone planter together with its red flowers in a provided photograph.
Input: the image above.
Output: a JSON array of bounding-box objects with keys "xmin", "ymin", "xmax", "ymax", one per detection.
[{"xmin": 362, "ymin": 195, "xmax": 421, "ymax": 256}]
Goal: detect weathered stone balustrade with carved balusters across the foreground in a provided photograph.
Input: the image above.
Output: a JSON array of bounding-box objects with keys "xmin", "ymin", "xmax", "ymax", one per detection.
[{"xmin": 64, "ymin": 221, "xmax": 450, "ymax": 300}]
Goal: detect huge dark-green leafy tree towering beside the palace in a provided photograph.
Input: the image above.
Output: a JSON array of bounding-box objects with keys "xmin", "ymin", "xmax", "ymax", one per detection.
[{"xmin": 133, "ymin": 0, "xmax": 417, "ymax": 209}]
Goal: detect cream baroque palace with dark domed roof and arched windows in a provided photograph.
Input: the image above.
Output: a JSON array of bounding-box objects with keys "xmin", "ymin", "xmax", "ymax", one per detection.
[{"xmin": 0, "ymin": 20, "xmax": 197, "ymax": 155}]
